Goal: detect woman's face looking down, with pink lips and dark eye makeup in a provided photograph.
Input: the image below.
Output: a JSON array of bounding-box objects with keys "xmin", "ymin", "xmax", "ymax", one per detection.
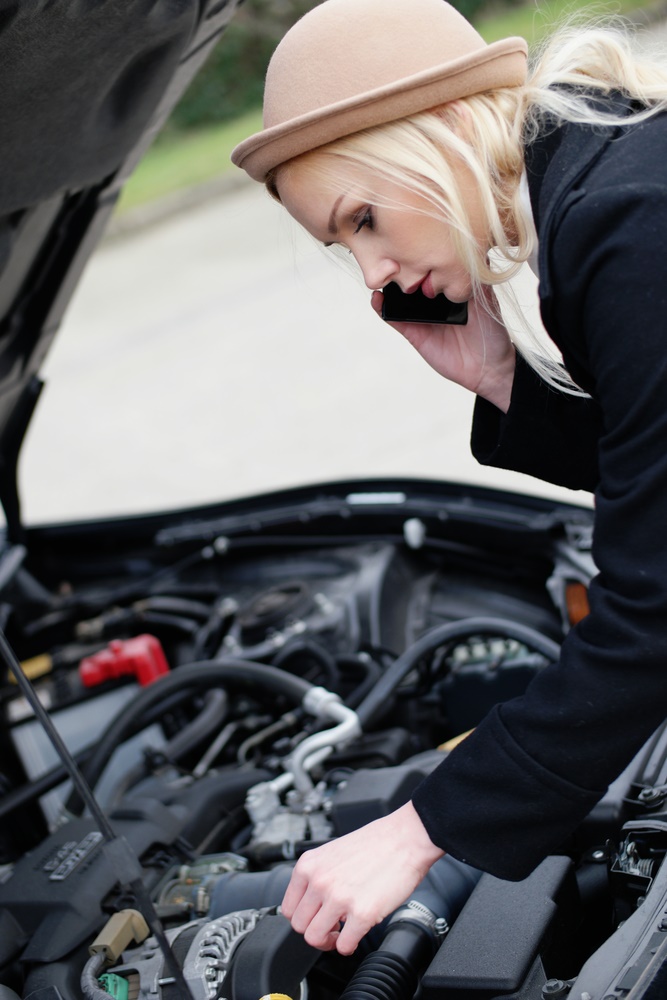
[{"xmin": 277, "ymin": 154, "xmax": 484, "ymax": 302}]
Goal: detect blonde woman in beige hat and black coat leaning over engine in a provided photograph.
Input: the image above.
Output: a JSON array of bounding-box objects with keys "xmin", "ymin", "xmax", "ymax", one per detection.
[{"xmin": 233, "ymin": 0, "xmax": 667, "ymax": 954}]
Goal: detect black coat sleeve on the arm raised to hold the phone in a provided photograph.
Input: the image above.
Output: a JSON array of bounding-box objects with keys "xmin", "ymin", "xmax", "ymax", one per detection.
[{"xmin": 471, "ymin": 355, "xmax": 602, "ymax": 493}]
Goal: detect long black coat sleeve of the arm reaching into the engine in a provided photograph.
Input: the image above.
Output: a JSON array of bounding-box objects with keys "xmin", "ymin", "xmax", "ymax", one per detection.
[{"xmin": 413, "ymin": 183, "xmax": 667, "ymax": 879}]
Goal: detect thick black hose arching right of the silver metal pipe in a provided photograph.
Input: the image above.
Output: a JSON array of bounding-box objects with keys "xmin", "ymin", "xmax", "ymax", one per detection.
[{"xmin": 357, "ymin": 617, "xmax": 560, "ymax": 729}]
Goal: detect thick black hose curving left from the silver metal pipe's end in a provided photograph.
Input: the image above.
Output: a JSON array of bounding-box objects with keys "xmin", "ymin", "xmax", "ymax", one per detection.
[{"xmin": 66, "ymin": 657, "xmax": 313, "ymax": 816}]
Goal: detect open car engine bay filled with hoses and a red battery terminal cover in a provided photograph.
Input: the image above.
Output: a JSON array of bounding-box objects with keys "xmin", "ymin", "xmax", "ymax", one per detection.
[{"xmin": 0, "ymin": 480, "xmax": 667, "ymax": 1000}]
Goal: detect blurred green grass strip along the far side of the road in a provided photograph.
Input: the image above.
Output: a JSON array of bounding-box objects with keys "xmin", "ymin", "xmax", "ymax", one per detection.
[{"xmin": 118, "ymin": 0, "xmax": 664, "ymax": 213}]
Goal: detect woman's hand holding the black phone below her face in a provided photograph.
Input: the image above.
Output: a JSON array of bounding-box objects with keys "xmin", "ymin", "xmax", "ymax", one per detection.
[{"xmin": 371, "ymin": 288, "xmax": 516, "ymax": 413}]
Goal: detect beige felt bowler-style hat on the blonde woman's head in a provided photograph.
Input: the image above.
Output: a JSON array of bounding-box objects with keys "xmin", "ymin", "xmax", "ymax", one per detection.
[{"xmin": 232, "ymin": 0, "xmax": 527, "ymax": 181}]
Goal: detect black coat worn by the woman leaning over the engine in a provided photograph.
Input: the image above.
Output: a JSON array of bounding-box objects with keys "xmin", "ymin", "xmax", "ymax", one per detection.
[{"xmin": 413, "ymin": 97, "xmax": 667, "ymax": 879}]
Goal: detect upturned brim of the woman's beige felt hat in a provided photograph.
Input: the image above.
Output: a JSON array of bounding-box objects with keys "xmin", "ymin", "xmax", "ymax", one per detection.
[{"xmin": 232, "ymin": 38, "xmax": 528, "ymax": 181}]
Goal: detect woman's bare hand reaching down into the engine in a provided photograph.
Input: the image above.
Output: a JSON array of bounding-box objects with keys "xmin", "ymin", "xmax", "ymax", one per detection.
[{"xmin": 281, "ymin": 802, "xmax": 444, "ymax": 955}]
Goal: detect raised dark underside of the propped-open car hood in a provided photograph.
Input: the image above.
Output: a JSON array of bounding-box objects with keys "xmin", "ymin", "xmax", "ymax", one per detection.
[{"xmin": 0, "ymin": 0, "xmax": 238, "ymax": 540}]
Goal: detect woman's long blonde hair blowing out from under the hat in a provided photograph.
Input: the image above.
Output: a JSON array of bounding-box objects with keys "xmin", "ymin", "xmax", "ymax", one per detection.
[{"xmin": 266, "ymin": 21, "xmax": 667, "ymax": 392}]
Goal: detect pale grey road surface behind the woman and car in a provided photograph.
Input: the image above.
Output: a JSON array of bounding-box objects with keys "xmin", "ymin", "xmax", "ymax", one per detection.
[{"xmin": 20, "ymin": 176, "xmax": 589, "ymax": 523}]
